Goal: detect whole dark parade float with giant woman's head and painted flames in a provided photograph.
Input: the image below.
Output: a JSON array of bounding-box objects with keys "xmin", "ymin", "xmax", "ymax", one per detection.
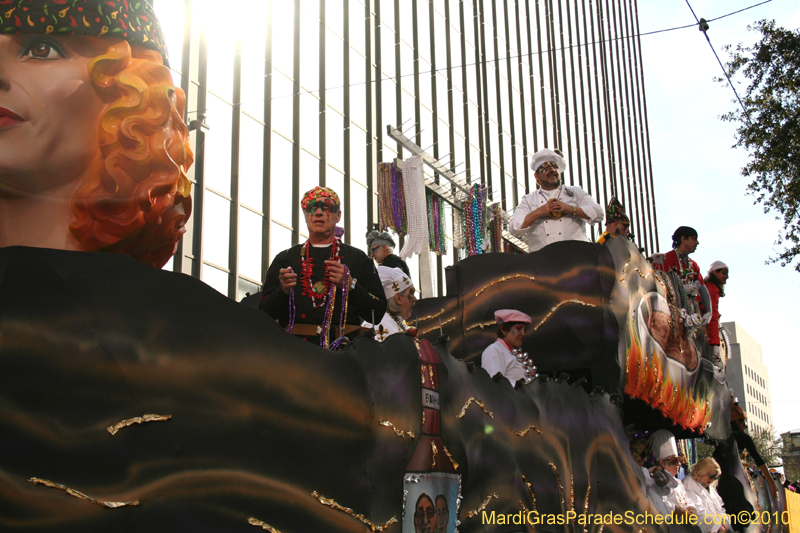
[{"xmin": 0, "ymin": 0, "xmax": 780, "ymax": 533}]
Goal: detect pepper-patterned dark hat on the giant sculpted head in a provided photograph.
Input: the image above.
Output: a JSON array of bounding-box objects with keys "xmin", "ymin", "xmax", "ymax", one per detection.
[{"xmin": 0, "ymin": 0, "xmax": 169, "ymax": 66}]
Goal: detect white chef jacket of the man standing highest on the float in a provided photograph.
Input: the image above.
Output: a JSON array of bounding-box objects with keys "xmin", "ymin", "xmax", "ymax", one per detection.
[{"xmin": 508, "ymin": 185, "xmax": 603, "ymax": 252}]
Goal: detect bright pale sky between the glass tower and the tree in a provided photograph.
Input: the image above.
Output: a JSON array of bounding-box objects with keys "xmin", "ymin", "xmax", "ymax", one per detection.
[{"xmin": 638, "ymin": 0, "xmax": 800, "ymax": 433}]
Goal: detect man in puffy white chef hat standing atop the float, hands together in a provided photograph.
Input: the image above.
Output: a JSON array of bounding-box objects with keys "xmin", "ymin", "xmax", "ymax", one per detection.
[{"xmin": 508, "ymin": 148, "xmax": 603, "ymax": 252}]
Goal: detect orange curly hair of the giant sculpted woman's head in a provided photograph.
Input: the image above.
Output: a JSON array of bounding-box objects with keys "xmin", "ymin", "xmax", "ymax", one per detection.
[{"xmin": 70, "ymin": 41, "xmax": 194, "ymax": 268}]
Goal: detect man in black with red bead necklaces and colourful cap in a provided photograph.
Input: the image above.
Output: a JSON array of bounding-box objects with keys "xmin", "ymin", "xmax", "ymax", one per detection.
[{"xmin": 259, "ymin": 187, "xmax": 386, "ymax": 346}]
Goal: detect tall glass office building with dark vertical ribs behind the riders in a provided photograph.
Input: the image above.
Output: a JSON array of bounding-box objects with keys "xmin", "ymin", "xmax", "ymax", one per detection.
[{"xmin": 155, "ymin": 0, "xmax": 657, "ymax": 300}]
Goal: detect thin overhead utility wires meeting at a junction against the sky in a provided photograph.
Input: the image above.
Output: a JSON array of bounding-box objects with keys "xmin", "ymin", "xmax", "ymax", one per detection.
[{"xmin": 184, "ymin": 0, "xmax": 773, "ymax": 114}]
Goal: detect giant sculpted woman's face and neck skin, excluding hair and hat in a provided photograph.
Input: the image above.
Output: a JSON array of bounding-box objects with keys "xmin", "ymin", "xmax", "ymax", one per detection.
[{"xmin": 0, "ymin": 35, "xmax": 109, "ymax": 200}]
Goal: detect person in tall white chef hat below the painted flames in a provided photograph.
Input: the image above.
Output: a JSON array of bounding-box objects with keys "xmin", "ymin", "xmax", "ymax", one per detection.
[{"xmin": 646, "ymin": 429, "xmax": 697, "ymax": 523}]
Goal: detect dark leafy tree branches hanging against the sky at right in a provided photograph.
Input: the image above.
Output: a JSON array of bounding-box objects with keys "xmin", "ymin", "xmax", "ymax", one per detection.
[{"xmin": 722, "ymin": 20, "xmax": 800, "ymax": 271}]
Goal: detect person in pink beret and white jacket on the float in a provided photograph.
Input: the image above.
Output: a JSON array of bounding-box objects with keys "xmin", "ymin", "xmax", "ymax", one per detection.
[{"xmin": 481, "ymin": 309, "xmax": 533, "ymax": 385}]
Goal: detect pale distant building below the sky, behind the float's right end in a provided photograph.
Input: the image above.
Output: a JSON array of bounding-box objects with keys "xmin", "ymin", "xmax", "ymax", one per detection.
[{"xmin": 722, "ymin": 322, "xmax": 775, "ymax": 431}]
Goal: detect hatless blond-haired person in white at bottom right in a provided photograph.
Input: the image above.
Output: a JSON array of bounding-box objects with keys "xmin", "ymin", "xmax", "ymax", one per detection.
[{"xmin": 683, "ymin": 457, "xmax": 730, "ymax": 533}]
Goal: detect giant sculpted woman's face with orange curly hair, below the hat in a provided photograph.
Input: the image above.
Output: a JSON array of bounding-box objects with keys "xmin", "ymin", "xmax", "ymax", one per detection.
[{"xmin": 0, "ymin": 34, "xmax": 193, "ymax": 267}]
